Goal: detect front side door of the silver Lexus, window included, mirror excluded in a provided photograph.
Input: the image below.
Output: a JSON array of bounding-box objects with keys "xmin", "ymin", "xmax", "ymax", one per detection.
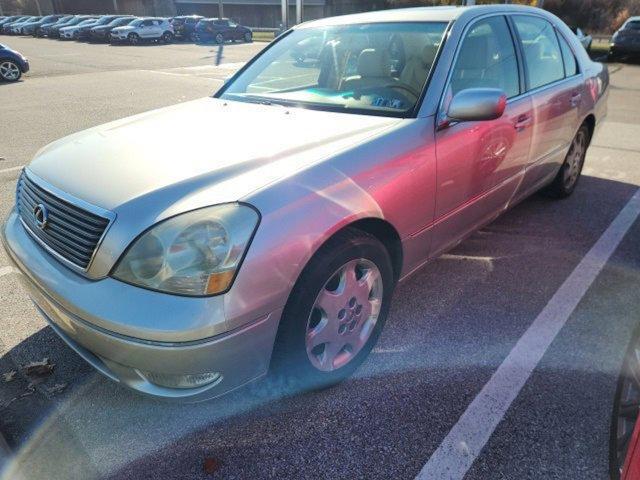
[{"xmin": 432, "ymin": 15, "xmax": 533, "ymax": 254}]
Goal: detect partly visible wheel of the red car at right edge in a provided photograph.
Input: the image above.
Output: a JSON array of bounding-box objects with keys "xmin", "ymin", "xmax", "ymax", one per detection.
[{"xmin": 609, "ymin": 329, "xmax": 640, "ymax": 480}]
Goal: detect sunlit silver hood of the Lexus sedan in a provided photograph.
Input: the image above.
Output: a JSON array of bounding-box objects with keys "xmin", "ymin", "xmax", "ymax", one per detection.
[{"xmin": 28, "ymin": 98, "xmax": 402, "ymax": 216}]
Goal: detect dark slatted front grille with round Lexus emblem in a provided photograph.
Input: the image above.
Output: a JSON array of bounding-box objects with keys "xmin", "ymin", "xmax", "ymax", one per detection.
[{"xmin": 16, "ymin": 172, "xmax": 109, "ymax": 270}]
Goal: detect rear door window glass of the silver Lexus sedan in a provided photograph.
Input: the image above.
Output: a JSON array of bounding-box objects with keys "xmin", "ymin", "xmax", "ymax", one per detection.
[{"xmin": 513, "ymin": 15, "xmax": 564, "ymax": 89}]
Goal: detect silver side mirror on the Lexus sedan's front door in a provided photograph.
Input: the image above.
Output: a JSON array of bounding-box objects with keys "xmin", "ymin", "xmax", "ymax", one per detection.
[{"xmin": 446, "ymin": 88, "xmax": 507, "ymax": 123}]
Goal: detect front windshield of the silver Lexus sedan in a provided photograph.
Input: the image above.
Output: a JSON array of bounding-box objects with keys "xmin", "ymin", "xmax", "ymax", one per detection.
[{"xmin": 219, "ymin": 22, "xmax": 446, "ymax": 116}]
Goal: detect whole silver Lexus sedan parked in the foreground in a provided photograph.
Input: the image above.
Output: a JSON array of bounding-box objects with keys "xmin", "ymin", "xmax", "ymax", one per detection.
[{"xmin": 0, "ymin": 5, "xmax": 609, "ymax": 401}]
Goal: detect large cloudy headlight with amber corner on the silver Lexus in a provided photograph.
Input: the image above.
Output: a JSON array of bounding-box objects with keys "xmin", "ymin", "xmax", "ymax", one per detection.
[{"xmin": 112, "ymin": 204, "xmax": 258, "ymax": 296}]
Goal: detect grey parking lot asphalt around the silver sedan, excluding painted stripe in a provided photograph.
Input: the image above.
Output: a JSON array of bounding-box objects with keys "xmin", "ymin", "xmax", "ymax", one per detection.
[{"xmin": 0, "ymin": 36, "xmax": 640, "ymax": 479}]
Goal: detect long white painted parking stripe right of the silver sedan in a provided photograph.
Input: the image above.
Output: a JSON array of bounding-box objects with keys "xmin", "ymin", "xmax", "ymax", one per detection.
[{"xmin": 416, "ymin": 190, "xmax": 640, "ymax": 480}]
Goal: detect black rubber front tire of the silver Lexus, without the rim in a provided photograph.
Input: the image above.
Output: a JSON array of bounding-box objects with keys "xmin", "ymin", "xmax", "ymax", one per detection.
[{"xmin": 271, "ymin": 229, "xmax": 395, "ymax": 390}]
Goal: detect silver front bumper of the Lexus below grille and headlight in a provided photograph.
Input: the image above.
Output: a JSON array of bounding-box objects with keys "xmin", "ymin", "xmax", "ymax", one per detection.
[{"xmin": 0, "ymin": 211, "xmax": 282, "ymax": 401}]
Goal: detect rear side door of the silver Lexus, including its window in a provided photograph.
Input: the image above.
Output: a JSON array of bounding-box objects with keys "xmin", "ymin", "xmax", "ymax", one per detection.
[{"xmin": 511, "ymin": 15, "xmax": 584, "ymax": 194}]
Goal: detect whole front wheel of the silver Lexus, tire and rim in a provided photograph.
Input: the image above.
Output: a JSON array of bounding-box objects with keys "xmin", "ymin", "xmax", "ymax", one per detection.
[{"xmin": 271, "ymin": 229, "xmax": 395, "ymax": 390}]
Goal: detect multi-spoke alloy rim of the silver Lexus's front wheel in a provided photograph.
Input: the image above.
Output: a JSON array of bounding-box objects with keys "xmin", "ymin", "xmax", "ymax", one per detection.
[{"xmin": 305, "ymin": 258, "xmax": 383, "ymax": 372}]
